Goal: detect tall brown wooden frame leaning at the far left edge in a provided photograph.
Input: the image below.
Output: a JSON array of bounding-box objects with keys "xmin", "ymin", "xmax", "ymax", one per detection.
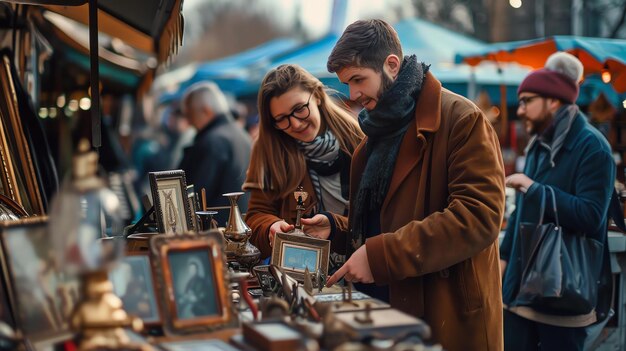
[{"xmin": 0, "ymin": 54, "xmax": 44, "ymax": 215}]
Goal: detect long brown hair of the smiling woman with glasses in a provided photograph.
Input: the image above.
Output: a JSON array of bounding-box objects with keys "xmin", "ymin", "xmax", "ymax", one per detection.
[{"xmin": 244, "ymin": 64, "xmax": 364, "ymax": 198}]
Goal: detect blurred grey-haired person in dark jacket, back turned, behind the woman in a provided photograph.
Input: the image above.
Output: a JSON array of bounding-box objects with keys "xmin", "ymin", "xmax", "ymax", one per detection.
[{"xmin": 179, "ymin": 82, "xmax": 252, "ymax": 225}]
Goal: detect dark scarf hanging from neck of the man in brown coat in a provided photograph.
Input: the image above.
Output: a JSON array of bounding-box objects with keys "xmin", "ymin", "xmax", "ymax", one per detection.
[{"xmin": 351, "ymin": 55, "xmax": 429, "ymax": 250}]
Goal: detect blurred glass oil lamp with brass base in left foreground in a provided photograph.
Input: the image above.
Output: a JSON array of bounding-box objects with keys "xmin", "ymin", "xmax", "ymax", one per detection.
[{"xmin": 49, "ymin": 139, "xmax": 150, "ymax": 350}]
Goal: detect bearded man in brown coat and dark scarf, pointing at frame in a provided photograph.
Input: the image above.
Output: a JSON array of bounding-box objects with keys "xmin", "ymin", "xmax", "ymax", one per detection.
[{"xmin": 303, "ymin": 20, "xmax": 504, "ymax": 351}]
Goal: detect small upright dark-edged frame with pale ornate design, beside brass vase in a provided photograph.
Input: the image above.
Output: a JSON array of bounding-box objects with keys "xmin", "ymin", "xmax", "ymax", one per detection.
[{"xmin": 149, "ymin": 170, "xmax": 193, "ymax": 234}]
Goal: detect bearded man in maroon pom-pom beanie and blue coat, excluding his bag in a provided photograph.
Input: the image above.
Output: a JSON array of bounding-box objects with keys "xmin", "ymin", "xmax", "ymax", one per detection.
[{"xmin": 500, "ymin": 52, "xmax": 615, "ymax": 350}]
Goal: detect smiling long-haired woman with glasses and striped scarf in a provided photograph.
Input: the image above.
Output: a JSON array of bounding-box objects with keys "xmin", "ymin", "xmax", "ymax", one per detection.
[{"xmin": 243, "ymin": 65, "xmax": 363, "ymax": 258}]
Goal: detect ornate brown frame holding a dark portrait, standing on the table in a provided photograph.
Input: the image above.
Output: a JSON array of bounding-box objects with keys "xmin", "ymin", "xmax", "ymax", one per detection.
[{"xmin": 150, "ymin": 230, "xmax": 234, "ymax": 334}]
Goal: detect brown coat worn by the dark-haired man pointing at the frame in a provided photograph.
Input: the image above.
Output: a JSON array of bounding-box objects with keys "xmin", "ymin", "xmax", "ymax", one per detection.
[{"xmin": 333, "ymin": 73, "xmax": 504, "ymax": 351}]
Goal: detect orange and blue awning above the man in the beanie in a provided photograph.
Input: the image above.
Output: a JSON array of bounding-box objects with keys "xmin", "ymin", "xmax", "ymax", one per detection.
[{"xmin": 455, "ymin": 36, "xmax": 626, "ymax": 93}]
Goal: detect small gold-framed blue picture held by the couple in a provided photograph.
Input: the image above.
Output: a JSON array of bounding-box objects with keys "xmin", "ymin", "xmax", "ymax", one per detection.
[{"xmin": 271, "ymin": 233, "xmax": 330, "ymax": 281}]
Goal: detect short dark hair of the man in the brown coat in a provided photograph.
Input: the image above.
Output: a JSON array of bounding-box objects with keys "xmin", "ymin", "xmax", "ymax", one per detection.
[{"xmin": 326, "ymin": 19, "xmax": 403, "ymax": 73}]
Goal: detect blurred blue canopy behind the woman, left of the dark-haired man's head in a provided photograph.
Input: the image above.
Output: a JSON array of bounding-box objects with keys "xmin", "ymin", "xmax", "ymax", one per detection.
[{"xmin": 155, "ymin": 38, "xmax": 298, "ymax": 103}]
